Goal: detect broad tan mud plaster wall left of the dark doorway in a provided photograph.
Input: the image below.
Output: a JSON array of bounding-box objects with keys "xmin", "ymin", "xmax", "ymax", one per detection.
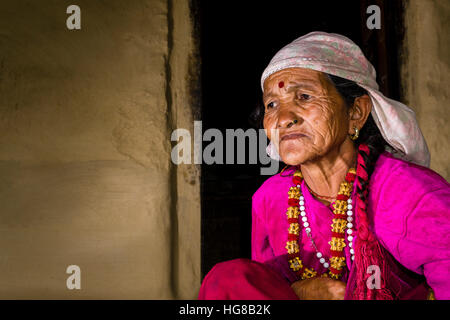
[{"xmin": 0, "ymin": 0, "xmax": 200, "ymax": 299}]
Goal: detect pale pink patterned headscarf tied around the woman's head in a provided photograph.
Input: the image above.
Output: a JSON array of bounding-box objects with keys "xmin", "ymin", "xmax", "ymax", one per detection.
[{"xmin": 261, "ymin": 32, "xmax": 430, "ymax": 167}]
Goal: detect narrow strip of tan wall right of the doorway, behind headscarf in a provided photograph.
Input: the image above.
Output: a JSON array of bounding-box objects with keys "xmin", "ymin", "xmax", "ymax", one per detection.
[{"xmin": 402, "ymin": 0, "xmax": 450, "ymax": 181}]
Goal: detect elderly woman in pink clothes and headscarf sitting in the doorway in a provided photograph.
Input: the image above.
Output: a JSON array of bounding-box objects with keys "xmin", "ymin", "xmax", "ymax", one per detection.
[{"xmin": 199, "ymin": 32, "xmax": 450, "ymax": 300}]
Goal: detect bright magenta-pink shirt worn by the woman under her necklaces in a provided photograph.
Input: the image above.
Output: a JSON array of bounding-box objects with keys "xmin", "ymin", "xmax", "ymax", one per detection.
[{"xmin": 252, "ymin": 152, "xmax": 450, "ymax": 299}]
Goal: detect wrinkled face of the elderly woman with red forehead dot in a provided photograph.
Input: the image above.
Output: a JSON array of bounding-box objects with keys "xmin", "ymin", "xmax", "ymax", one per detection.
[{"xmin": 263, "ymin": 68, "xmax": 350, "ymax": 165}]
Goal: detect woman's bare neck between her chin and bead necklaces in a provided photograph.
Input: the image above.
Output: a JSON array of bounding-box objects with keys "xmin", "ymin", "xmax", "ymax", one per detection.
[{"xmin": 301, "ymin": 140, "xmax": 357, "ymax": 205}]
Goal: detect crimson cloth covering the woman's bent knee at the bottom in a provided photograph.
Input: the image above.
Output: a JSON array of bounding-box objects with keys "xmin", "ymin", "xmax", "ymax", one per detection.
[{"xmin": 198, "ymin": 259, "xmax": 298, "ymax": 300}]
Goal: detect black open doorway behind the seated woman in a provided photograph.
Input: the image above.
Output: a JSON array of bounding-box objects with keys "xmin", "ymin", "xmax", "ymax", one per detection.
[{"xmin": 194, "ymin": 0, "xmax": 403, "ymax": 277}]
